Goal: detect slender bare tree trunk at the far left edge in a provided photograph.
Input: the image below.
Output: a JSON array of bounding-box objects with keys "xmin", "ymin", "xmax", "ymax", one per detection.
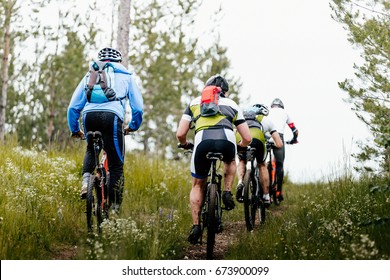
[{"xmin": 0, "ymin": 0, "xmax": 16, "ymax": 142}]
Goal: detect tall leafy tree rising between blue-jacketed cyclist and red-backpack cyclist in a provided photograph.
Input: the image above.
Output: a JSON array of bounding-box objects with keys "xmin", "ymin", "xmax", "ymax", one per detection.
[{"xmin": 130, "ymin": 0, "xmax": 242, "ymax": 157}]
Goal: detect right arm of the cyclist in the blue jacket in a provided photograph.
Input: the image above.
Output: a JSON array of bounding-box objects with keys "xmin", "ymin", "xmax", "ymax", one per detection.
[{"xmin": 128, "ymin": 76, "xmax": 144, "ymax": 131}]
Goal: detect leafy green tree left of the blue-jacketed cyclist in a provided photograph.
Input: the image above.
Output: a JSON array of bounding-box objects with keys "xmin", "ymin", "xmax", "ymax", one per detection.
[{"xmin": 8, "ymin": 2, "xmax": 99, "ymax": 146}]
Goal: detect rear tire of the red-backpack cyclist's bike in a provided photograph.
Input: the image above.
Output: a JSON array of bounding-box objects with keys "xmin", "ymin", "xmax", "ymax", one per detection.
[{"xmin": 206, "ymin": 184, "xmax": 218, "ymax": 260}]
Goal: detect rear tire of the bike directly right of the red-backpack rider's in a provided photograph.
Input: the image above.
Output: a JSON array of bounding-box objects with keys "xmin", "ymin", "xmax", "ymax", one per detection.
[{"xmin": 243, "ymin": 170, "xmax": 257, "ymax": 231}]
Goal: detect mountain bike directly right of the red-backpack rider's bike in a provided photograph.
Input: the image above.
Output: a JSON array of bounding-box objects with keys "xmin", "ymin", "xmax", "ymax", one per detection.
[{"xmin": 243, "ymin": 147, "xmax": 265, "ymax": 231}]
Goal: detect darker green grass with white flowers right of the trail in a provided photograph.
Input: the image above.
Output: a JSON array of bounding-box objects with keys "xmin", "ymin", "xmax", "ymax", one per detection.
[{"xmin": 227, "ymin": 176, "xmax": 390, "ymax": 260}]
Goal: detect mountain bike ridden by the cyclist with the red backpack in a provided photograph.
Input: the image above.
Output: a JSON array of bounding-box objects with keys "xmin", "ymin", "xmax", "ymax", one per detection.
[{"xmin": 178, "ymin": 148, "xmax": 223, "ymax": 259}]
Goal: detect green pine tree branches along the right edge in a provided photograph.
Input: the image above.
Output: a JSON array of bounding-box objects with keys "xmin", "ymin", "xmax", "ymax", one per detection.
[{"xmin": 332, "ymin": 0, "xmax": 390, "ymax": 174}]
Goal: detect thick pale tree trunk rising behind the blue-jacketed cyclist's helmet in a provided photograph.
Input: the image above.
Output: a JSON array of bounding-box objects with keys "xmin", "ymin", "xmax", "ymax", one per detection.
[{"xmin": 117, "ymin": 0, "xmax": 131, "ymax": 67}]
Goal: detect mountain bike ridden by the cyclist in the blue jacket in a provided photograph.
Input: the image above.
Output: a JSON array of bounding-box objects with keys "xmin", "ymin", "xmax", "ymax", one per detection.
[{"xmin": 86, "ymin": 131, "xmax": 109, "ymax": 233}]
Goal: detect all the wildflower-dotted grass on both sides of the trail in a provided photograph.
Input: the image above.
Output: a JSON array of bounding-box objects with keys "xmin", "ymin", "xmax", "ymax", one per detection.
[{"xmin": 0, "ymin": 140, "xmax": 390, "ymax": 260}]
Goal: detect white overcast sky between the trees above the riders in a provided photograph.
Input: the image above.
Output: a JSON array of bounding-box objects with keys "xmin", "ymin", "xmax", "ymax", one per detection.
[{"xmin": 194, "ymin": 0, "xmax": 369, "ymax": 182}]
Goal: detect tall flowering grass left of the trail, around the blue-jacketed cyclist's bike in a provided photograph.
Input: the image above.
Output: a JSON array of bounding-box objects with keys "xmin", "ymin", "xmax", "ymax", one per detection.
[{"xmin": 0, "ymin": 143, "xmax": 195, "ymax": 259}]
